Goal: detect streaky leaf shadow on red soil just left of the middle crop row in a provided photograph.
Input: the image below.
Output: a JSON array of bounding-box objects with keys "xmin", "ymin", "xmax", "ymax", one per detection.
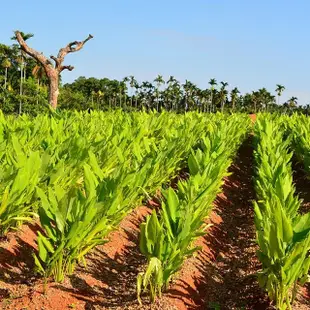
[{"xmin": 57, "ymin": 209, "xmax": 151, "ymax": 310}]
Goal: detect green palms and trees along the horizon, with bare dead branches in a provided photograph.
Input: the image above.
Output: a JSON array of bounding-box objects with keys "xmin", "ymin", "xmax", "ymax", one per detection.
[{"xmin": 0, "ymin": 32, "xmax": 310, "ymax": 115}]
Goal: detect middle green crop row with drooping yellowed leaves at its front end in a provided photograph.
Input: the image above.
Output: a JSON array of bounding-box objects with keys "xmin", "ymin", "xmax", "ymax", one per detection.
[{"xmin": 137, "ymin": 114, "xmax": 249, "ymax": 302}]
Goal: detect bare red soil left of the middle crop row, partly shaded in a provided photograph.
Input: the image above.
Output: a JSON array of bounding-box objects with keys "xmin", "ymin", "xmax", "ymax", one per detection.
[{"xmin": 0, "ymin": 207, "xmax": 150, "ymax": 310}]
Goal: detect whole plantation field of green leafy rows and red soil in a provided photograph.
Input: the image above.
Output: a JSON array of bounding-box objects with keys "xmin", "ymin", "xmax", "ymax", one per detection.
[{"xmin": 0, "ymin": 111, "xmax": 310, "ymax": 310}]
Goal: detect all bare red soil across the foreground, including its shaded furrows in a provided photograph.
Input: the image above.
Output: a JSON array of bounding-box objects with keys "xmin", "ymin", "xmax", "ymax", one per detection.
[{"xmin": 0, "ymin": 139, "xmax": 310, "ymax": 310}]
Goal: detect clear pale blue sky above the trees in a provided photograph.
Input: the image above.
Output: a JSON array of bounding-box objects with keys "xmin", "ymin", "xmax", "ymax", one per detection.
[{"xmin": 0, "ymin": 0, "xmax": 310, "ymax": 104}]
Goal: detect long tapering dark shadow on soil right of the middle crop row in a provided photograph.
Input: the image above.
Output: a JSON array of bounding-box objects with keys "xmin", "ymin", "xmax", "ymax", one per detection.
[{"xmin": 191, "ymin": 137, "xmax": 269, "ymax": 310}]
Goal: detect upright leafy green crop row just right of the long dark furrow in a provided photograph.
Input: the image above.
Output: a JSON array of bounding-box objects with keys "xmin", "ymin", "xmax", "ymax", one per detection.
[{"xmin": 254, "ymin": 115, "xmax": 310, "ymax": 310}]
